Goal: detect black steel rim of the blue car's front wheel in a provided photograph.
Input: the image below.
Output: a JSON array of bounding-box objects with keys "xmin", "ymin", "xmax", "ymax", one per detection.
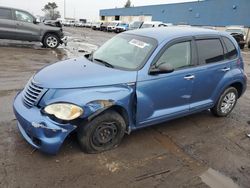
[{"xmin": 92, "ymin": 122, "xmax": 118, "ymax": 147}]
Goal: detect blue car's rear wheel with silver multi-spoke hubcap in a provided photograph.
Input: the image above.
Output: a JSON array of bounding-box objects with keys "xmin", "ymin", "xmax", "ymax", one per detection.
[{"xmin": 211, "ymin": 87, "xmax": 238, "ymax": 117}]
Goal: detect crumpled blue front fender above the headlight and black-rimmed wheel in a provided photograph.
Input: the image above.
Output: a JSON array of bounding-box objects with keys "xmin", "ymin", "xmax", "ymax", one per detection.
[{"xmin": 39, "ymin": 84, "xmax": 135, "ymax": 130}]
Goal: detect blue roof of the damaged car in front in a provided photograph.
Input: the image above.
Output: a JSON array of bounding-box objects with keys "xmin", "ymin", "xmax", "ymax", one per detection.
[{"xmin": 126, "ymin": 26, "xmax": 221, "ymax": 43}]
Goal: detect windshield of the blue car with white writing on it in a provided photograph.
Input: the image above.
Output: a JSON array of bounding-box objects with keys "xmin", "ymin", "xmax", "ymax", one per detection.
[{"xmin": 92, "ymin": 34, "xmax": 157, "ymax": 70}]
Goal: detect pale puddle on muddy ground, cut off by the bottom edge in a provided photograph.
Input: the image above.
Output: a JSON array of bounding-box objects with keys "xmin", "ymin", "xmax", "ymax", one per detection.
[{"xmin": 200, "ymin": 168, "xmax": 239, "ymax": 188}]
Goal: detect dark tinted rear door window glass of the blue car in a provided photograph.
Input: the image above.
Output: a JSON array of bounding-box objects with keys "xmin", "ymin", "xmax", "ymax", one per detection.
[{"xmin": 196, "ymin": 39, "xmax": 224, "ymax": 64}]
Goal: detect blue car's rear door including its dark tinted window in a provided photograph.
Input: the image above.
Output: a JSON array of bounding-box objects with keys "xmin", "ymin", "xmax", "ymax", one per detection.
[{"xmin": 190, "ymin": 36, "xmax": 231, "ymax": 111}]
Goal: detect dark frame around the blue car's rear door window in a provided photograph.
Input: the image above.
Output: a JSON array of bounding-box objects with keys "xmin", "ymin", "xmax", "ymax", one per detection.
[{"xmin": 194, "ymin": 35, "xmax": 228, "ymax": 67}]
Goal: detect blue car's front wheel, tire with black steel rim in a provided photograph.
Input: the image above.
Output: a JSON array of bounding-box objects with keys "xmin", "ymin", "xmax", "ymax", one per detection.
[{"xmin": 77, "ymin": 111, "xmax": 126, "ymax": 153}]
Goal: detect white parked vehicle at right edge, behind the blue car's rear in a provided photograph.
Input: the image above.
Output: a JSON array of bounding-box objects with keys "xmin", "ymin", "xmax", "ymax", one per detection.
[{"xmin": 226, "ymin": 26, "xmax": 247, "ymax": 49}]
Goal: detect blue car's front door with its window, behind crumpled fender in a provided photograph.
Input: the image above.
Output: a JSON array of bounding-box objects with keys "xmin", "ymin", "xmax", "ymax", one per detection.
[{"xmin": 136, "ymin": 39, "xmax": 195, "ymax": 127}]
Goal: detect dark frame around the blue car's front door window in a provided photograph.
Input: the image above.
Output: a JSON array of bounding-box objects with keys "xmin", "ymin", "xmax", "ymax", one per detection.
[{"xmin": 148, "ymin": 36, "xmax": 198, "ymax": 75}]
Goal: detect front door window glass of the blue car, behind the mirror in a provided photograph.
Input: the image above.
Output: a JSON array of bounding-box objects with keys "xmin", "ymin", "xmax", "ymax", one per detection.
[{"xmin": 156, "ymin": 41, "xmax": 191, "ymax": 69}]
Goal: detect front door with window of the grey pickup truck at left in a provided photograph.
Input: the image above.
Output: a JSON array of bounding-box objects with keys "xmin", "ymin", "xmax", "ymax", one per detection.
[{"xmin": 14, "ymin": 10, "xmax": 41, "ymax": 41}]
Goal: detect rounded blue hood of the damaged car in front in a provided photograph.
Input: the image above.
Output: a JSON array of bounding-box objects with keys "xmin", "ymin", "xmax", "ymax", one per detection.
[{"xmin": 33, "ymin": 57, "xmax": 137, "ymax": 88}]
